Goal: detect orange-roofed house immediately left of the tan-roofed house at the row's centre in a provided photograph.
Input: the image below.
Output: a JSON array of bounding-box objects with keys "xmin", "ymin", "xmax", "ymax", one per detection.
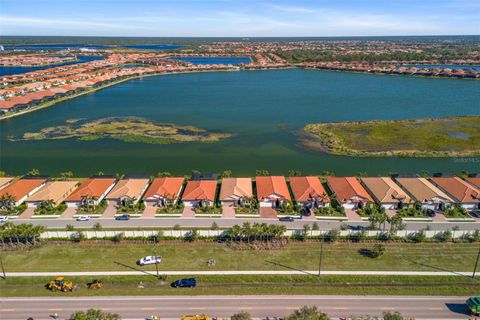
[{"xmin": 182, "ymin": 180, "xmax": 217, "ymax": 207}]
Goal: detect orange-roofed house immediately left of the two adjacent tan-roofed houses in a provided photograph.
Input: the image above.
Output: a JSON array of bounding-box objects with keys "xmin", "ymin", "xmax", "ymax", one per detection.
[{"xmin": 327, "ymin": 177, "xmax": 374, "ymax": 210}]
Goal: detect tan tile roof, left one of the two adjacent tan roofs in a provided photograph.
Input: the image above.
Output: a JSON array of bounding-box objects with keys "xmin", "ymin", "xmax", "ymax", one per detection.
[{"xmin": 361, "ymin": 177, "xmax": 412, "ymax": 203}]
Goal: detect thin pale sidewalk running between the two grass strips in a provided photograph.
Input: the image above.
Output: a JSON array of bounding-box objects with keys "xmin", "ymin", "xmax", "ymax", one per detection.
[{"xmin": 5, "ymin": 270, "xmax": 478, "ymax": 277}]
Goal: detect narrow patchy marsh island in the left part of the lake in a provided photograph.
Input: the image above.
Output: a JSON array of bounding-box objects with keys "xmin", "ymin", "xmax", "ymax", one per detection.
[{"xmin": 11, "ymin": 117, "xmax": 232, "ymax": 144}]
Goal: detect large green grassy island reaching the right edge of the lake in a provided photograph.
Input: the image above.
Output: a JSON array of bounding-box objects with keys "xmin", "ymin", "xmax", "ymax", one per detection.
[{"xmin": 302, "ymin": 116, "xmax": 480, "ymax": 157}]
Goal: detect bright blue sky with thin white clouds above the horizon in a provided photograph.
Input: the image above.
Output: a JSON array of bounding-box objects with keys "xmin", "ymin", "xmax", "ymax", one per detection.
[{"xmin": 0, "ymin": 0, "xmax": 480, "ymax": 37}]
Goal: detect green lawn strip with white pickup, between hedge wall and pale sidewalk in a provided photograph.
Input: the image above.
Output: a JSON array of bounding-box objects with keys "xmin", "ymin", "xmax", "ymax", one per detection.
[{"xmin": 2, "ymin": 241, "xmax": 478, "ymax": 272}]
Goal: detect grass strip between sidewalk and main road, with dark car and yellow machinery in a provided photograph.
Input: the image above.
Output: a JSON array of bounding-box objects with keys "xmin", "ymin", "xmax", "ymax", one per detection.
[{"xmin": 0, "ymin": 275, "xmax": 479, "ymax": 297}]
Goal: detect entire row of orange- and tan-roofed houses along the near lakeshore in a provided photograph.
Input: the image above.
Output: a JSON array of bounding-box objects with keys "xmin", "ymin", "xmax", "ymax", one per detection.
[{"xmin": 0, "ymin": 176, "xmax": 480, "ymax": 214}]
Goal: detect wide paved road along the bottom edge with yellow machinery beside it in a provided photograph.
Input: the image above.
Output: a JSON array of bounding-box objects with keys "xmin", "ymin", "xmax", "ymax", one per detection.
[{"xmin": 0, "ymin": 296, "xmax": 468, "ymax": 320}]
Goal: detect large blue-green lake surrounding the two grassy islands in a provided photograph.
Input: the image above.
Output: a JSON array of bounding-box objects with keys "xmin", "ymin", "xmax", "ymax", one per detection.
[{"xmin": 0, "ymin": 69, "xmax": 480, "ymax": 175}]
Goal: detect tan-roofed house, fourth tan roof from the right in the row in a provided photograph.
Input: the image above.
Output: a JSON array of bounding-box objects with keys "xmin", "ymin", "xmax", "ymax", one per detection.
[{"xmin": 105, "ymin": 178, "xmax": 150, "ymax": 205}]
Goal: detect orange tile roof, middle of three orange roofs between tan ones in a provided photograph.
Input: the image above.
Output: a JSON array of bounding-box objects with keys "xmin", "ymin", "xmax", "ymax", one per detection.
[{"xmin": 289, "ymin": 176, "xmax": 330, "ymax": 202}]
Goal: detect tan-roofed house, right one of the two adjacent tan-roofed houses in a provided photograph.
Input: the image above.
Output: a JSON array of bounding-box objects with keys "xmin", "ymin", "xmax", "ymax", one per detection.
[{"xmin": 396, "ymin": 178, "xmax": 455, "ymax": 210}]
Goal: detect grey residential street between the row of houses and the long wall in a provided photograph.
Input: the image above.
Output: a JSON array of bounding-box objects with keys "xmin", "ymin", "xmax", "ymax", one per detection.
[{"xmin": 11, "ymin": 217, "xmax": 480, "ymax": 231}]
